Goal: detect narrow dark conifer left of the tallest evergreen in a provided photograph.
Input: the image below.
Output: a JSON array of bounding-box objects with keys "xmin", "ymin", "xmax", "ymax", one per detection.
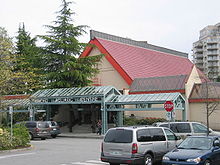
[{"xmin": 13, "ymin": 24, "xmax": 42, "ymax": 94}]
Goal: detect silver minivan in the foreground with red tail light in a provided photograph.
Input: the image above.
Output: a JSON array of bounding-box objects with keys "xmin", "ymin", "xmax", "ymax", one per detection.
[{"xmin": 101, "ymin": 126, "xmax": 182, "ymax": 165}]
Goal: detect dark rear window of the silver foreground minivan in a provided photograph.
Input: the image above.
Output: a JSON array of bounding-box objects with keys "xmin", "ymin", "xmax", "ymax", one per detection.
[{"xmin": 104, "ymin": 129, "xmax": 133, "ymax": 143}]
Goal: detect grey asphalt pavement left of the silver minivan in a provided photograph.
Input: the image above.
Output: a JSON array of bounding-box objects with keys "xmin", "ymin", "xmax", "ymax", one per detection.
[{"xmin": 0, "ymin": 137, "xmax": 107, "ymax": 165}]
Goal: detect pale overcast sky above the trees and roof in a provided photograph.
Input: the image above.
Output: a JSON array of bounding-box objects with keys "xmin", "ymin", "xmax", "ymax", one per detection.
[{"xmin": 0, "ymin": 0, "xmax": 220, "ymax": 59}]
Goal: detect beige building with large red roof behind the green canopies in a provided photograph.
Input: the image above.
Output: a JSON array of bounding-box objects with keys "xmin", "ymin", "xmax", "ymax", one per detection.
[{"xmin": 80, "ymin": 30, "xmax": 220, "ymax": 130}]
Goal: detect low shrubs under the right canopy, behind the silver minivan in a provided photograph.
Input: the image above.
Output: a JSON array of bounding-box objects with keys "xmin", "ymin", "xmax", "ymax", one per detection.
[{"xmin": 124, "ymin": 117, "xmax": 166, "ymax": 126}]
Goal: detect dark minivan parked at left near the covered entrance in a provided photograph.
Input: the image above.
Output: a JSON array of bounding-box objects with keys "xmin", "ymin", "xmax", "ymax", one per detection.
[{"xmin": 24, "ymin": 121, "xmax": 50, "ymax": 140}]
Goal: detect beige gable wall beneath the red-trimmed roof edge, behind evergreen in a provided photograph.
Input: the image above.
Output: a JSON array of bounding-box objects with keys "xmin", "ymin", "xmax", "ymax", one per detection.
[{"xmin": 89, "ymin": 48, "xmax": 129, "ymax": 90}]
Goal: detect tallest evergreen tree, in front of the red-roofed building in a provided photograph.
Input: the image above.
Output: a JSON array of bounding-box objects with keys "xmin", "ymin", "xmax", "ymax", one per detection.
[{"xmin": 39, "ymin": 0, "xmax": 102, "ymax": 88}]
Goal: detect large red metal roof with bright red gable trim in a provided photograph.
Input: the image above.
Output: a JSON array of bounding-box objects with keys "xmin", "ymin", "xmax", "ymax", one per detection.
[{"xmin": 81, "ymin": 38, "xmax": 193, "ymax": 85}]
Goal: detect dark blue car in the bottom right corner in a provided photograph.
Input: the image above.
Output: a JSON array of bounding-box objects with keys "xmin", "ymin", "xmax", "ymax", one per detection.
[{"xmin": 162, "ymin": 136, "xmax": 220, "ymax": 165}]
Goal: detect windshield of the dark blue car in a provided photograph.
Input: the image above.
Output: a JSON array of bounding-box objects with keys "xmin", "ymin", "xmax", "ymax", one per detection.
[{"xmin": 178, "ymin": 137, "xmax": 212, "ymax": 150}]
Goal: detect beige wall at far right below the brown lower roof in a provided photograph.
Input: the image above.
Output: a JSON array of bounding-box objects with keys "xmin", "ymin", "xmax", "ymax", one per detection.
[{"xmin": 190, "ymin": 103, "xmax": 220, "ymax": 130}]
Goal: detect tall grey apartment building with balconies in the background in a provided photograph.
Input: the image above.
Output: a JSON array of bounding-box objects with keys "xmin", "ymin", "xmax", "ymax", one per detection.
[{"xmin": 193, "ymin": 23, "xmax": 220, "ymax": 81}]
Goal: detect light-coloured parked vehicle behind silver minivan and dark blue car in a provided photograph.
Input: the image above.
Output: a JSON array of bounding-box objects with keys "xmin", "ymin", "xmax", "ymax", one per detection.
[{"xmin": 153, "ymin": 122, "xmax": 220, "ymax": 138}]
